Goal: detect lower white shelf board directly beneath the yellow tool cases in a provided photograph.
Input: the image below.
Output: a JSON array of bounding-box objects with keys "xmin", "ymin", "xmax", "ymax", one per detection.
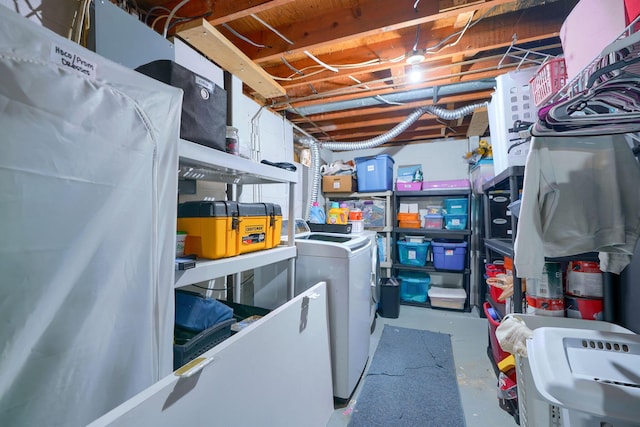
[{"xmin": 175, "ymin": 246, "xmax": 297, "ymax": 288}]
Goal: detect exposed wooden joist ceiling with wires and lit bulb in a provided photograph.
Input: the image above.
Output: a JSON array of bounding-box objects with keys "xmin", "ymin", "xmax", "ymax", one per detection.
[{"xmin": 138, "ymin": 0, "xmax": 578, "ymax": 144}]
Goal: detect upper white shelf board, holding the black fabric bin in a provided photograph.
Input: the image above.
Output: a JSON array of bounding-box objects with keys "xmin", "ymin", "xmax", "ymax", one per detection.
[{"xmin": 178, "ymin": 139, "xmax": 298, "ymax": 185}]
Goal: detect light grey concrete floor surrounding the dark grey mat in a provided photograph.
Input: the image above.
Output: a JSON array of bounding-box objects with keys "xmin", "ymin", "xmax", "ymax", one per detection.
[{"xmin": 327, "ymin": 305, "xmax": 517, "ymax": 427}]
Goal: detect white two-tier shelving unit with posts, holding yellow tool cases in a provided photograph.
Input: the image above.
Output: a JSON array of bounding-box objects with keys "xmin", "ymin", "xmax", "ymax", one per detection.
[{"xmin": 175, "ymin": 140, "xmax": 298, "ymax": 302}]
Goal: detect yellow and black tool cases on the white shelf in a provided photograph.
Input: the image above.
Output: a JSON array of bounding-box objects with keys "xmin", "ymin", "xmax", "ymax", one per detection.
[{"xmin": 178, "ymin": 201, "xmax": 282, "ymax": 259}]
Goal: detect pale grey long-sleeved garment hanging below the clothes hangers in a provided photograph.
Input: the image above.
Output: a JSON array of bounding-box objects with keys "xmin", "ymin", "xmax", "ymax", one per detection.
[{"xmin": 514, "ymin": 135, "xmax": 640, "ymax": 278}]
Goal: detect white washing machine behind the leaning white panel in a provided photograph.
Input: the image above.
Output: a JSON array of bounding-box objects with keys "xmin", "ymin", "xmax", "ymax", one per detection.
[{"xmin": 292, "ymin": 224, "xmax": 372, "ymax": 399}]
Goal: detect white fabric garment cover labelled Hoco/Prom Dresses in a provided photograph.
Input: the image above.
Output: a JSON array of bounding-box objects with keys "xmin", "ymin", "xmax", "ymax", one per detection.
[{"xmin": 0, "ymin": 7, "xmax": 182, "ymax": 427}]
